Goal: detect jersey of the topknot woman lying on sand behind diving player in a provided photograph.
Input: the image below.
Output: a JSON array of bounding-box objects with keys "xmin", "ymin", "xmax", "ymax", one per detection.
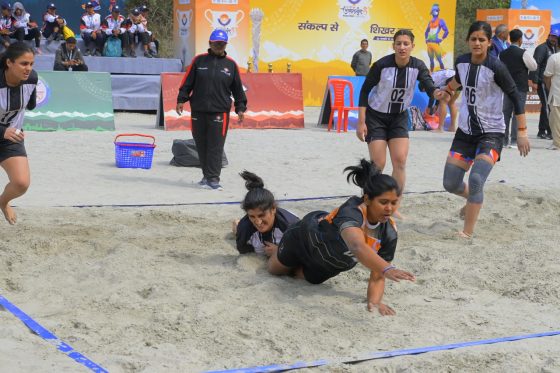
[{"xmin": 235, "ymin": 207, "xmax": 299, "ymax": 255}]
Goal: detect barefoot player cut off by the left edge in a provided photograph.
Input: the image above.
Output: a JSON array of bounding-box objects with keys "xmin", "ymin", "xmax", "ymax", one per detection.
[{"xmin": 0, "ymin": 42, "xmax": 38, "ymax": 224}]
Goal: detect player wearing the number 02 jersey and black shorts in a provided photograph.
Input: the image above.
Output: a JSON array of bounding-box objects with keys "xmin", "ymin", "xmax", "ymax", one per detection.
[{"xmin": 356, "ymin": 30, "xmax": 445, "ymax": 214}]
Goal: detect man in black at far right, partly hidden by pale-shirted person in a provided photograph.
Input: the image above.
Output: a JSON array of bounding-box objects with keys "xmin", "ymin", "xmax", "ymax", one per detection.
[{"xmin": 531, "ymin": 29, "xmax": 560, "ymax": 140}]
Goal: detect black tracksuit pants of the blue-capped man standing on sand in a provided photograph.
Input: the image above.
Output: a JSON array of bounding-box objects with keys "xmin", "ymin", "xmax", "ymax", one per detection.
[{"xmin": 191, "ymin": 112, "xmax": 229, "ymax": 182}]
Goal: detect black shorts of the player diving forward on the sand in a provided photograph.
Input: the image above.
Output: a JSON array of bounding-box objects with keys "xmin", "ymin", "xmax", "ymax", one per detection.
[{"xmin": 277, "ymin": 211, "xmax": 356, "ymax": 284}]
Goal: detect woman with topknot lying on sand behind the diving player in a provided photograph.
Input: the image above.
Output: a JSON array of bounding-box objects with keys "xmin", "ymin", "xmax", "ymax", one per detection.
[{"xmin": 233, "ymin": 171, "xmax": 299, "ymax": 256}]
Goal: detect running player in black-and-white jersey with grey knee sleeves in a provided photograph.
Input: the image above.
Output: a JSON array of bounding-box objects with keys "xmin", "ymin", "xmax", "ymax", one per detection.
[{"xmin": 443, "ymin": 21, "xmax": 530, "ymax": 238}]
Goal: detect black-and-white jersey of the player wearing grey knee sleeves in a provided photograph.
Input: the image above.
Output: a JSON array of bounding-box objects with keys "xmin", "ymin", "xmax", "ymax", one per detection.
[{"xmin": 455, "ymin": 53, "xmax": 525, "ymax": 136}]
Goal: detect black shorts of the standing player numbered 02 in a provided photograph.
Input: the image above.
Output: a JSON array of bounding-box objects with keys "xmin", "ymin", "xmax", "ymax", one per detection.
[{"xmin": 366, "ymin": 106, "xmax": 408, "ymax": 144}]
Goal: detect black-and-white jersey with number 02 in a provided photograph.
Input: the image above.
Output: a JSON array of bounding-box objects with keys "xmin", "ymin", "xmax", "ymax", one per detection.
[{"xmin": 360, "ymin": 53, "xmax": 436, "ymax": 114}]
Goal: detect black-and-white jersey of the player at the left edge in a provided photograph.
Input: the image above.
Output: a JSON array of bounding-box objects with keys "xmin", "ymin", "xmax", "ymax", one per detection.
[{"xmin": 0, "ymin": 69, "xmax": 38, "ymax": 138}]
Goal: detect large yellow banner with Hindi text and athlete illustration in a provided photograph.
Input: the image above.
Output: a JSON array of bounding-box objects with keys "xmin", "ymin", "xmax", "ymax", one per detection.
[{"xmin": 249, "ymin": 0, "xmax": 456, "ymax": 106}]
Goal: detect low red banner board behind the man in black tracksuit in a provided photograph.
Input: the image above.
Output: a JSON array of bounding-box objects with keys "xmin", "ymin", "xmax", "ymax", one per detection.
[{"xmin": 158, "ymin": 73, "xmax": 304, "ymax": 131}]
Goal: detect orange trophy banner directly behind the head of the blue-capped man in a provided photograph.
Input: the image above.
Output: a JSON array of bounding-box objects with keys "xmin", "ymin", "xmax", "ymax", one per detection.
[{"xmin": 173, "ymin": 0, "xmax": 250, "ymax": 70}]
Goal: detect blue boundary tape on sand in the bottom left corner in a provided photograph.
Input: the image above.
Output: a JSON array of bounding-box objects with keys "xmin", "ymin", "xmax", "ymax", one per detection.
[{"xmin": 0, "ymin": 295, "xmax": 109, "ymax": 373}]
